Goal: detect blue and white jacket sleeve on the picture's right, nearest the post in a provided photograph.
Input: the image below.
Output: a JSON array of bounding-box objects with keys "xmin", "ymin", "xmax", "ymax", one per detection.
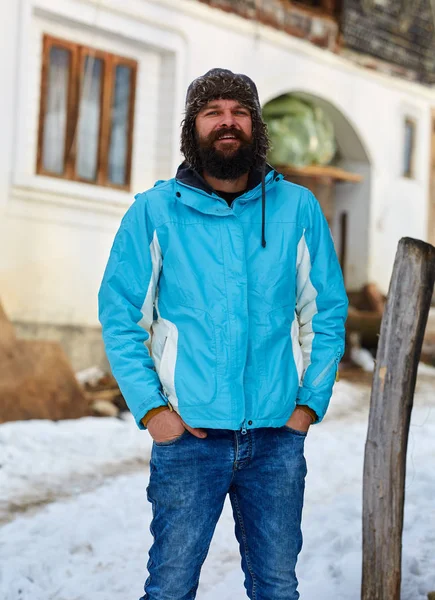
[{"xmin": 296, "ymin": 192, "xmax": 348, "ymax": 422}]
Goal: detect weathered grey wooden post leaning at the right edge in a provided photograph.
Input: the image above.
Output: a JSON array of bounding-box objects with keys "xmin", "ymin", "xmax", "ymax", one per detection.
[{"xmin": 361, "ymin": 238, "xmax": 435, "ymax": 600}]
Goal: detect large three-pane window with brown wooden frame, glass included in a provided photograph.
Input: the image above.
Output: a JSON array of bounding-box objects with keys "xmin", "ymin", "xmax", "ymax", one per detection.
[{"xmin": 36, "ymin": 36, "xmax": 137, "ymax": 189}]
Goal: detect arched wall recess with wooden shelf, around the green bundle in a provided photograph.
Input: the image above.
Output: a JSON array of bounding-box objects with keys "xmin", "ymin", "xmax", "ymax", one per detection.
[{"xmin": 263, "ymin": 91, "xmax": 371, "ymax": 291}]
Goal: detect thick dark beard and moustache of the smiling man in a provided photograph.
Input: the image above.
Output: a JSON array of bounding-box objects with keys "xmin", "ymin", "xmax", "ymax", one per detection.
[{"xmin": 195, "ymin": 127, "xmax": 255, "ymax": 181}]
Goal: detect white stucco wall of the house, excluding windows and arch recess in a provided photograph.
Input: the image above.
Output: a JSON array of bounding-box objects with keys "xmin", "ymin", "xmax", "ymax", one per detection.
[{"xmin": 0, "ymin": 0, "xmax": 434, "ymax": 325}]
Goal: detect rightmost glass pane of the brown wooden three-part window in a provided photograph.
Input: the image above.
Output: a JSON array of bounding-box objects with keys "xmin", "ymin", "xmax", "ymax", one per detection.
[{"xmin": 108, "ymin": 65, "xmax": 132, "ymax": 185}]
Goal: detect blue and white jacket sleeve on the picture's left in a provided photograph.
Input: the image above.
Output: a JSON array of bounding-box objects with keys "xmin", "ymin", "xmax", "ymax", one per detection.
[{"xmin": 98, "ymin": 195, "xmax": 167, "ymax": 429}]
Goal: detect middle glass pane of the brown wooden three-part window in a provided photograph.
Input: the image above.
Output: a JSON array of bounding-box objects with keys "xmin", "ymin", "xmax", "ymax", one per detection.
[{"xmin": 76, "ymin": 56, "xmax": 103, "ymax": 181}]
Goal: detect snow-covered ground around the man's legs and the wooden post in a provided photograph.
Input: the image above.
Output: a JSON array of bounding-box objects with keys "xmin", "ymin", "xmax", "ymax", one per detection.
[{"xmin": 0, "ymin": 367, "xmax": 435, "ymax": 600}]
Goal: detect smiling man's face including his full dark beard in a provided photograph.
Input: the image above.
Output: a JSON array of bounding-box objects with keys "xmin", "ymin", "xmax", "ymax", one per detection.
[{"xmin": 195, "ymin": 100, "xmax": 254, "ymax": 180}]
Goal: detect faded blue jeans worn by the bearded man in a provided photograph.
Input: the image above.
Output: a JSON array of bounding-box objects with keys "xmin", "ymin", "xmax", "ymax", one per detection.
[{"xmin": 141, "ymin": 427, "xmax": 306, "ymax": 600}]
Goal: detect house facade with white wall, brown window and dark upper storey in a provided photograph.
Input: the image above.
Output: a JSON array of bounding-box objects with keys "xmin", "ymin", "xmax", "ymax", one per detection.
[{"xmin": 0, "ymin": 0, "xmax": 435, "ymax": 368}]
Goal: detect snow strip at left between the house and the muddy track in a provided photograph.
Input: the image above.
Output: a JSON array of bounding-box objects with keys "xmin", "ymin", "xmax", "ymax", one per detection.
[{"xmin": 0, "ymin": 414, "xmax": 151, "ymax": 520}]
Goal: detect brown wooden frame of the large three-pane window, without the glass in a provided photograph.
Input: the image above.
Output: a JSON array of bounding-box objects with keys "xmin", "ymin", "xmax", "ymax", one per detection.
[{"xmin": 36, "ymin": 35, "xmax": 137, "ymax": 191}]
